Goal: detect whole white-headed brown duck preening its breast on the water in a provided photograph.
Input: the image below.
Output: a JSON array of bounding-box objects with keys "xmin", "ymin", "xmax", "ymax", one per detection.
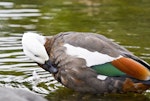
[{"xmin": 22, "ymin": 32, "xmax": 150, "ymax": 94}]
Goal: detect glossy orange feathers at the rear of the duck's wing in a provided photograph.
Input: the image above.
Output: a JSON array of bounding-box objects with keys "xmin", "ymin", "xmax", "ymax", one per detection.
[{"xmin": 112, "ymin": 57, "xmax": 150, "ymax": 80}]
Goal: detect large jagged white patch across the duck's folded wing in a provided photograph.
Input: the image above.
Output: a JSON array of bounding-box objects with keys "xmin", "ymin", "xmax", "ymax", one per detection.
[{"xmin": 64, "ymin": 44, "xmax": 116, "ymax": 67}]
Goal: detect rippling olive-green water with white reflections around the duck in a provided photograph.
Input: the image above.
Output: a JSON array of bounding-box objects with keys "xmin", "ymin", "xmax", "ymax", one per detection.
[{"xmin": 0, "ymin": 0, "xmax": 150, "ymax": 101}]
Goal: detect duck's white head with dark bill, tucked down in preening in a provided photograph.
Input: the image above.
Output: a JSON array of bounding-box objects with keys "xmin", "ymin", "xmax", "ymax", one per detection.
[{"xmin": 22, "ymin": 32, "xmax": 57, "ymax": 73}]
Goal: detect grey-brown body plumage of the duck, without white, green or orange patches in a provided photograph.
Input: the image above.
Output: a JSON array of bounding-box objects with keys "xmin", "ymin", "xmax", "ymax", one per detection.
[{"xmin": 41, "ymin": 33, "xmax": 150, "ymax": 93}]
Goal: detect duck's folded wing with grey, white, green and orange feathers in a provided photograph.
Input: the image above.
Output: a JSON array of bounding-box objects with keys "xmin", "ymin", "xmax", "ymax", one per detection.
[{"xmin": 64, "ymin": 33, "xmax": 150, "ymax": 80}]
